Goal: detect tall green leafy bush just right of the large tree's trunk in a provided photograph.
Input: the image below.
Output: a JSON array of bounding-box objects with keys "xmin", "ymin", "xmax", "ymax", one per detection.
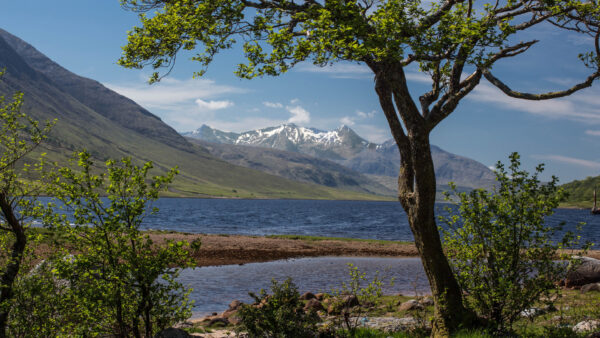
[{"xmin": 440, "ymin": 153, "xmax": 578, "ymax": 332}]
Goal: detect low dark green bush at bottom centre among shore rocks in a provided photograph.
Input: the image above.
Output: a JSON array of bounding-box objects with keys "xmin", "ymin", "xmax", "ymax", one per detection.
[{"xmin": 238, "ymin": 278, "xmax": 319, "ymax": 337}]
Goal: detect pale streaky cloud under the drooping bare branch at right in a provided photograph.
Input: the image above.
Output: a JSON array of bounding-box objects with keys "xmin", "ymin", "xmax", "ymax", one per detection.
[{"xmin": 467, "ymin": 82, "xmax": 600, "ymax": 124}]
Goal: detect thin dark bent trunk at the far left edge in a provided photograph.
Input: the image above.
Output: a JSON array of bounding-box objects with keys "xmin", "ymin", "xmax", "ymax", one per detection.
[{"xmin": 0, "ymin": 193, "xmax": 27, "ymax": 338}]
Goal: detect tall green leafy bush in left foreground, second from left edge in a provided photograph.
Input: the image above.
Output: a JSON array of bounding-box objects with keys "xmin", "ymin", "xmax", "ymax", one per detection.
[{"xmin": 51, "ymin": 152, "xmax": 190, "ymax": 337}]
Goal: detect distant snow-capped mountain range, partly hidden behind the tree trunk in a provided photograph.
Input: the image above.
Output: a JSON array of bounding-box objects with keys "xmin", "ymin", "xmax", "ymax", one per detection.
[{"xmin": 183, "ymin": 124, "xmax": 494, "ymax": 191}]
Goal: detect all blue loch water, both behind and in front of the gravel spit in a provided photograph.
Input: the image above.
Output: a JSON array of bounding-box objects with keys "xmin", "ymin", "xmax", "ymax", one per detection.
[{"xmin": 145, "ymin": 198, "xmax": 600, "ymax": 316}]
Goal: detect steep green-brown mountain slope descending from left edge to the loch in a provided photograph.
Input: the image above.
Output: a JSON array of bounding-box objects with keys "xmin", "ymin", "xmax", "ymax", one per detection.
[{"xmin": 0, "ymin": 31, "xmax": 384, "ymax": 199}]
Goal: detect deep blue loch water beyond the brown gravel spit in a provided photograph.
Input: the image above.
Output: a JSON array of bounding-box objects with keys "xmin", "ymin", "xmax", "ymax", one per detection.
[{"xmin": 145, "ymin": 198, "xmax": 600, "ymax": 243}]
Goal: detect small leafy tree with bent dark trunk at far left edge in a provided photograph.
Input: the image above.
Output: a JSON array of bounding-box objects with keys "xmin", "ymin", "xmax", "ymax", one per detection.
[{"xmin": 0, "ymin": 78, "xmax": 52, "ymax": 337}]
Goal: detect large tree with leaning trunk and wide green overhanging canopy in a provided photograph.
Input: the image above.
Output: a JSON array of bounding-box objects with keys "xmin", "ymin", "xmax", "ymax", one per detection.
[{"xmin": 119, "ymin": 0, "xmax": 600, "ymax": 335}]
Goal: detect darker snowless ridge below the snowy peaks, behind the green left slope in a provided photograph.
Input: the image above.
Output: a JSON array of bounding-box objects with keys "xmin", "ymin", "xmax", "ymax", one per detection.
[{"xmin": 189, "ymin": 138, "xmax": 396, "ymax": 196}]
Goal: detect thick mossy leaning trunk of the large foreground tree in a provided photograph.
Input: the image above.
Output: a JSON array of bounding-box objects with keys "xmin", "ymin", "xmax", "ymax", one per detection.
[{"xmin": 367, "ymin": 62, "xmax": 475, "ymax": 337}]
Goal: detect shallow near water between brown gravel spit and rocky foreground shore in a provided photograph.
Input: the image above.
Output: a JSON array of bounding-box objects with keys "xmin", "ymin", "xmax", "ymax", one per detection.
[{"xmin": 180, "ymin": 257, "xmax": 429, "ymax": 317}]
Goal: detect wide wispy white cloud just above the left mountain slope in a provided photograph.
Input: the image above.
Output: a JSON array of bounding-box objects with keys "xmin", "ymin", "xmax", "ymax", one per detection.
[{"xmin": 104, "ymin": 78, "xmax": 247, "ymax": 109}]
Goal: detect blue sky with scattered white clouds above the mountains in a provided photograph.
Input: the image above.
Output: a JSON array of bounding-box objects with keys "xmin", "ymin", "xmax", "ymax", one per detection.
[{"xmin": 0, "ymin": 0, "xmax": 600, "ymax": 183}]
